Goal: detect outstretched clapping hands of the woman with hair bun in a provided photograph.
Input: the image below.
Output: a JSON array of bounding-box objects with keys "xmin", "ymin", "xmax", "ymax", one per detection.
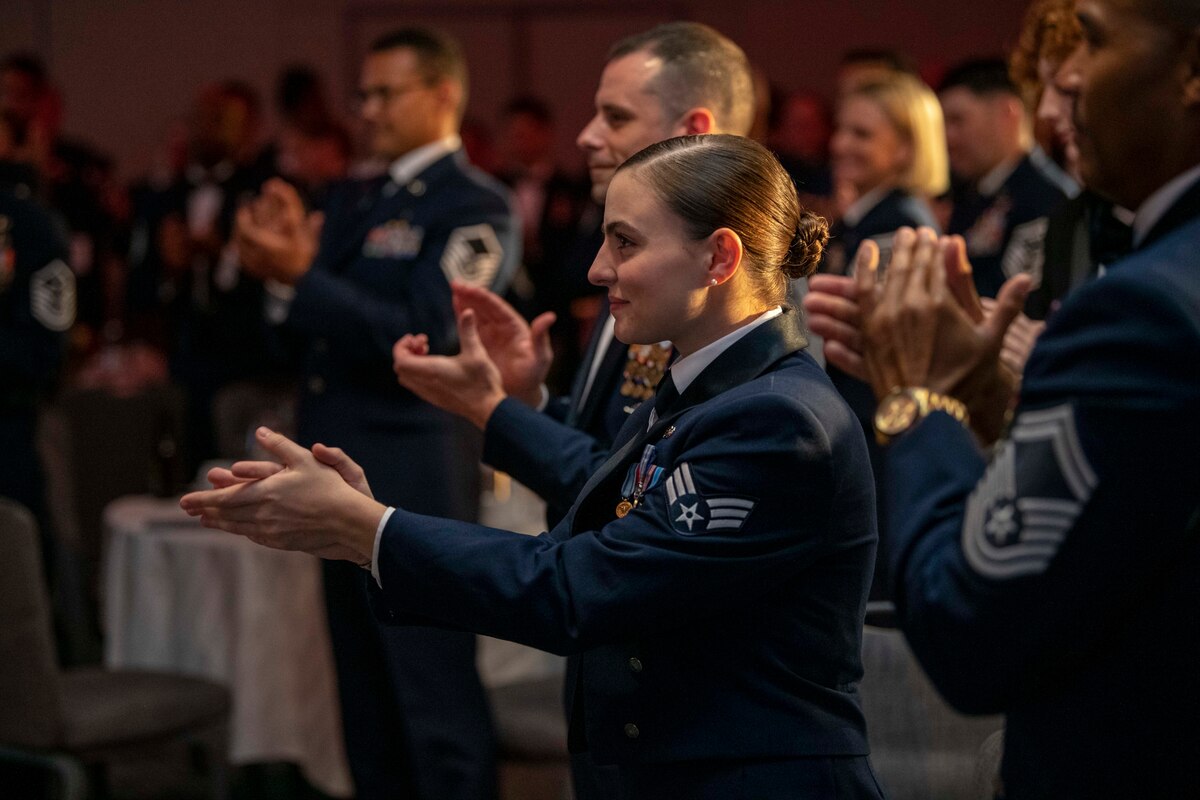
[{"xmin": 180, "ymin": 428, "xmax": 385, "ymax": 563}]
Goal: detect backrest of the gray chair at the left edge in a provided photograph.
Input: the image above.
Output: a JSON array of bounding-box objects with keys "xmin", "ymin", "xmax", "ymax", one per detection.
[{"xmin": 0, "ymin": 498, "xmax": 62, "ymax": 748}]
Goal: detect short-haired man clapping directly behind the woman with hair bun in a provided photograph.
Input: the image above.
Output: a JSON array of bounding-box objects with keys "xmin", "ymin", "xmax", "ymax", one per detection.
[{"xmin": 461, "ymin": 23, "xmax": 754, "ymax": 527}]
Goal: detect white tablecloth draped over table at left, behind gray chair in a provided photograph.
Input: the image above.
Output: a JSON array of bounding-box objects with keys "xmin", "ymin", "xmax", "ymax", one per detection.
[{"xmin": 104, "ymin": 497, "xmax": 352, "ymax": 796}]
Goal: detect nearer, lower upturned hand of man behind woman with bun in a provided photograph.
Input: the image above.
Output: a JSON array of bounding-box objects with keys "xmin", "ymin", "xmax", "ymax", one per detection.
[{"xmin": 391, "ymin": 308, "xmax": 508, "ymax": 429}]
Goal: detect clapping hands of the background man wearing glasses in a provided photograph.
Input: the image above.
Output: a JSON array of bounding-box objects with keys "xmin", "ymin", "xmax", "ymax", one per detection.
[{"xmin": 234, "ymin": 178, "xmax": 324, "ymax": 285}]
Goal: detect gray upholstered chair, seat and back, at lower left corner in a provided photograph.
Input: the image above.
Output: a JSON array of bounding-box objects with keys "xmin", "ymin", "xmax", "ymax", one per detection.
[{"xmin": 0, "ymin": 498, "xmax": 229, "ymax": 799}]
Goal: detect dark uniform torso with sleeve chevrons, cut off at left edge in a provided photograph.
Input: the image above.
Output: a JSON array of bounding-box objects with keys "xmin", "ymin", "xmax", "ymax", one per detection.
[{"xmin": 0, "ymin": 190, "xmax": 76, "ymax": 556}]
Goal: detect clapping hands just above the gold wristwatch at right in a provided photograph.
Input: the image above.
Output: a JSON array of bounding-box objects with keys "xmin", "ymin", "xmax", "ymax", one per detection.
[{"xmin": 804, "ymin": 228, "xmax": 1036, "ymax": 445}]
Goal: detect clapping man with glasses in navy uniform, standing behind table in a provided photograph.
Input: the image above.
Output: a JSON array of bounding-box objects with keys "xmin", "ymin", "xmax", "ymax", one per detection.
[{"xmin": 239, "ymin": 29, "xmax": 520, "ymax": 800}]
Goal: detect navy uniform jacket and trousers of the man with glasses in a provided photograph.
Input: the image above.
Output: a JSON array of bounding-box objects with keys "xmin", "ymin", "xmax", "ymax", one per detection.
[{"xmin": 288, "ymin": 154, "xmax": 520, "ymax": 800}]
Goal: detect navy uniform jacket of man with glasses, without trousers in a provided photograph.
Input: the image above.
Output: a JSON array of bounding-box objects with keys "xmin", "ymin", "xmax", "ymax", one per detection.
[{"xmin": 288, "ymin": 154, "xmax": 520, "ymax": 506}]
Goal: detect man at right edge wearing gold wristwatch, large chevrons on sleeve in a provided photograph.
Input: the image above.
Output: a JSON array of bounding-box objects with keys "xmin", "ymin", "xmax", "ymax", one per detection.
[{"xmin": 806, "ymin": 0, "xmax": 1200, "ymax": 800}]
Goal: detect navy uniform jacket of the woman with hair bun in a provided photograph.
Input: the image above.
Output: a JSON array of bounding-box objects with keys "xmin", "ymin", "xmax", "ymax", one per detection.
[{"xmin": 376, "ymin": 313, "xmax": 876, "ymax": 765}]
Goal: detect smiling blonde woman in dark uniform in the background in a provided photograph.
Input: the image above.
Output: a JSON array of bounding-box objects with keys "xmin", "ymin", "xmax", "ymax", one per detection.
[{"xmin": 821, "ymin": 72, "xmax": 950, "ymax": 600}]
